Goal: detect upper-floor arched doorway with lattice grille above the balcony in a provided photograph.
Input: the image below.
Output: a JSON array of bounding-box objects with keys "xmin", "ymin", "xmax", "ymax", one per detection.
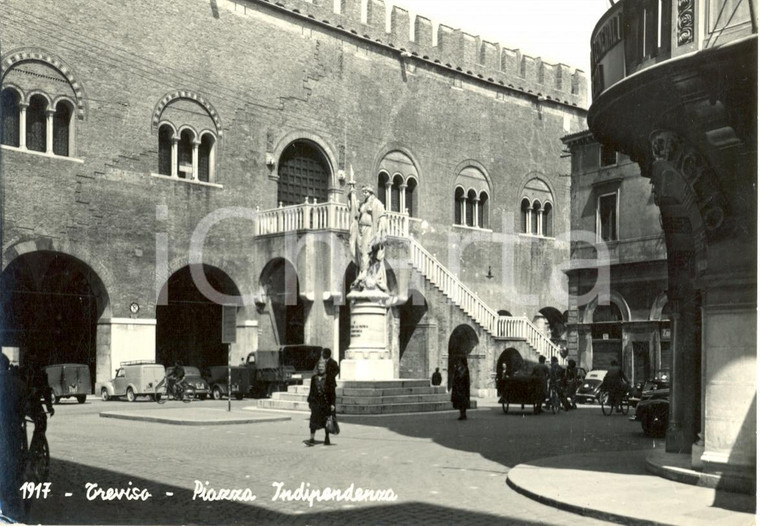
[{"xmin": 277, "ymin": 140, "xmax": 332, "ymax": 206}]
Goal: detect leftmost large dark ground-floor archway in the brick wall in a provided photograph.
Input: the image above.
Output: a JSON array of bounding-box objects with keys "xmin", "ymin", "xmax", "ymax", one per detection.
[{"xmin": 0, "ymin": 251, "xmax": 108, "ymax": 388}]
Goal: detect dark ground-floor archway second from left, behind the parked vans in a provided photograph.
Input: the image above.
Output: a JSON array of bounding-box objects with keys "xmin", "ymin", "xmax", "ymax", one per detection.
[{"xmin": 156, "ymin": 265, "xmax": 240, "ymax": 368}]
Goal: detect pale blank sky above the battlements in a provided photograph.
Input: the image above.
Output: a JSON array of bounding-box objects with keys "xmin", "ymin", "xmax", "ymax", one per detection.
[{"xmin": 386, "ymin": 0, "xmax": 610, "ymax": 74}]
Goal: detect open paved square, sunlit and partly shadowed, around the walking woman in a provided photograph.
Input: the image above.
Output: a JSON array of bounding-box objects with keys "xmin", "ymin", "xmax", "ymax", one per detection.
[{"xmin": 22, "ymin": 400, "xmax": 653, "ymax": 525}]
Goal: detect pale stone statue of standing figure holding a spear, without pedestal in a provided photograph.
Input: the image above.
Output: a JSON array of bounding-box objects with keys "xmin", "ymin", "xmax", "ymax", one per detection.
[{"xmin": 348, "ymin": 181, "xmax": 388, "ymax": 293}]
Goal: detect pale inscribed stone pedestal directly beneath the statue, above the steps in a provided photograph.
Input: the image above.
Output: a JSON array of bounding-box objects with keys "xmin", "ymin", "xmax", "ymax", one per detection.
[{"xmin": 340, "ymin": 290, "xmax": 394, "ymax": 381}]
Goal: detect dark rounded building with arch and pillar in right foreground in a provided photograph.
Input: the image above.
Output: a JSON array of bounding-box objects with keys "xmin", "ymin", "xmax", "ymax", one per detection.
[{"xmin": 588, "ymin": 0, "xmax": 757, "ymax": 493}]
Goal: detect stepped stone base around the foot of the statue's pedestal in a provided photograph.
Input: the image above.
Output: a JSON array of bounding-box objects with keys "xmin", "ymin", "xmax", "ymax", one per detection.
[{"xmin": 256, "ymin": 380, "xmax": 477, "ymax": 415}]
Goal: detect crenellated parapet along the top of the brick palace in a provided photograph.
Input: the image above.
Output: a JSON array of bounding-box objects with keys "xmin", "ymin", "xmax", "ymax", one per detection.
[{"xmin": 232, "ymin": 0, "xmax": 588, "ymax": 108}]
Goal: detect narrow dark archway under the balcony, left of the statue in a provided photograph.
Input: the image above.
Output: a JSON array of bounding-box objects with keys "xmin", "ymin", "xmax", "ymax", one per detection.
[{"xmin": 259, "ymin": 258, "xmax": 306, "ymax": 345}]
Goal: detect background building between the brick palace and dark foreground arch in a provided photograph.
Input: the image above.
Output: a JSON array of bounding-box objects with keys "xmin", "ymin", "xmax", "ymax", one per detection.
[{"xmin": 562, "ymin": 130, "xmax": 672, "ymax": 385}]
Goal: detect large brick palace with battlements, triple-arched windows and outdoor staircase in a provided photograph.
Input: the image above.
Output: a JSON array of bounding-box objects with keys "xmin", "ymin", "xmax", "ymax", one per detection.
[{"xmin": 0, "ymin": 0, "xmax": 586, "ymax": 393}]
